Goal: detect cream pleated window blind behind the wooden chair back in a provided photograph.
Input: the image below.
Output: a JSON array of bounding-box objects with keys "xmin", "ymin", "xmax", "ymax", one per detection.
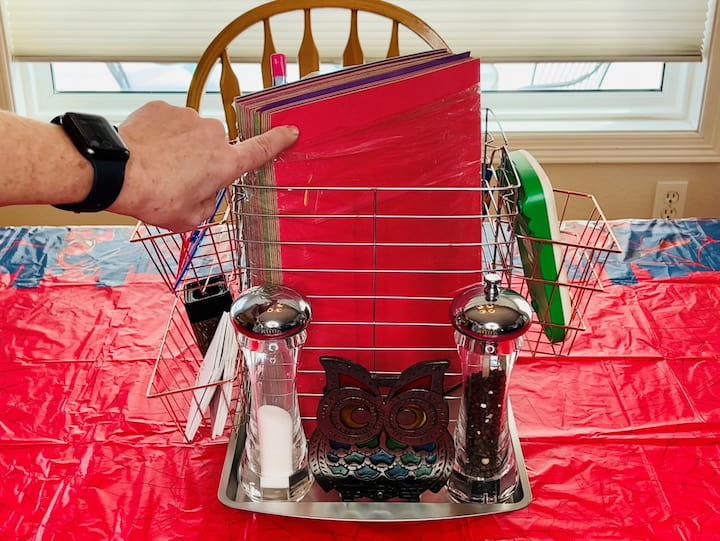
[{"xmin": 0, "ymin": 0, "xmax": 715, "ymax": 62}]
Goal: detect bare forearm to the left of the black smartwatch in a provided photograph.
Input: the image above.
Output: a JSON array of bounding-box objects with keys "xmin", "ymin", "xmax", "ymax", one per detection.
[{"xmin": 0, "ymin": 111, "xmax": 93, "ymax": 206}]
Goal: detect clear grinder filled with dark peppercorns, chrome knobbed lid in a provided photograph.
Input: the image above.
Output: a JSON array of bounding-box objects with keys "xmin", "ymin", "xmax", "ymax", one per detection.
[{"xmin": 448, "ymin": 273, "xmax": 532, "ymax": 503}]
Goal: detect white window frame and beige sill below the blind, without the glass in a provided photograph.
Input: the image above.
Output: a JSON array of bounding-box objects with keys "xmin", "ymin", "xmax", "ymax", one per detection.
[{"xmin": 12, "ymin": 40, "xmax": 720, "ymax": 163}]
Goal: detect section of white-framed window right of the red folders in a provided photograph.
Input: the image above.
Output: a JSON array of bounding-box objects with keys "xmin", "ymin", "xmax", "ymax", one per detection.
[{"xmin": 483, "ymin": 62, "xmax": 707, "ymax": 132}]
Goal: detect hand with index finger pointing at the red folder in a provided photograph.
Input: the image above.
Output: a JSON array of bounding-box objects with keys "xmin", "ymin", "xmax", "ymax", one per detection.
[{"xmin": 108, "ymin": 101, "xmax": 298, "ymax": 232}]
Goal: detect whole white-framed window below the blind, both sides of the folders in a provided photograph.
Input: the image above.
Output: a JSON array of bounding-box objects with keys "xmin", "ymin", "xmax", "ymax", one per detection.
[{"xmin": 14, "ymin": 58, "xmax": 705, "ymax": 132}]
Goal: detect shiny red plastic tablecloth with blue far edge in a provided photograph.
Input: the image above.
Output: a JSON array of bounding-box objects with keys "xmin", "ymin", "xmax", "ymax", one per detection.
[{"xmin": 0, "ymin": 220, "xmax": 720, "ymax": 541}]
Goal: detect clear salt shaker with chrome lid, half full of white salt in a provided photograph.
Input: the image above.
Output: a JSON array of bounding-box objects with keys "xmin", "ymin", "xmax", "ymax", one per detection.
[{"xmin": 230, "ymin": 285, "xmax": 312, "ymax": 501}]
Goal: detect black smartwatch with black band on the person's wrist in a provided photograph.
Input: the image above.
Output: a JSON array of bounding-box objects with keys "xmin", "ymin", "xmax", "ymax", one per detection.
[{"xmin": 52, "ymin": 113, "xmax": 130, "ymax": 212}]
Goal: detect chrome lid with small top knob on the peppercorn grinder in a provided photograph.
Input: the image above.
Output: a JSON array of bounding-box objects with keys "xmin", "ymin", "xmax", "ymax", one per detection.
[{"xmin": 450, "ymin": 273, "xmax": 532, "ymax": 342}]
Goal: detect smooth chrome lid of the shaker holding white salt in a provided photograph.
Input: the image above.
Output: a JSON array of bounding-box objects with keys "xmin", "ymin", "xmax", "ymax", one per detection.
[{"xmin": 230, "ymin": 285, "xmax": 311, "ymax": 340}]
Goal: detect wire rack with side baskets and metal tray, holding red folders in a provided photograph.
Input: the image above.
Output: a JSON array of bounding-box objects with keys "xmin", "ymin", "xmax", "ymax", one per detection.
[{"xmin": 132, "ymin": 111, "xmax": 618, "ymax": 521}]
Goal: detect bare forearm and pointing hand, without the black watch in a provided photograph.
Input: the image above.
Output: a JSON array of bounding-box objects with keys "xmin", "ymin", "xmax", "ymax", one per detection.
[{"xmin": 0, "ymin": 102, "xmax": 298, "ymax": 232}]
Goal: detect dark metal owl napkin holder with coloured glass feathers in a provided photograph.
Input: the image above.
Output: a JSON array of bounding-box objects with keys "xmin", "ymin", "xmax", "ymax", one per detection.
[{"xmin": 309, "ymin": 357, "xmax": 454, "ymax": 502}]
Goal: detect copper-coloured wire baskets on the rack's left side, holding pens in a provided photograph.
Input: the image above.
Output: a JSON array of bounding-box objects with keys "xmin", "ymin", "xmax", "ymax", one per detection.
[{"xmin": 130, "ymin": 192, "xmax": 247, "ymax": 443}]
